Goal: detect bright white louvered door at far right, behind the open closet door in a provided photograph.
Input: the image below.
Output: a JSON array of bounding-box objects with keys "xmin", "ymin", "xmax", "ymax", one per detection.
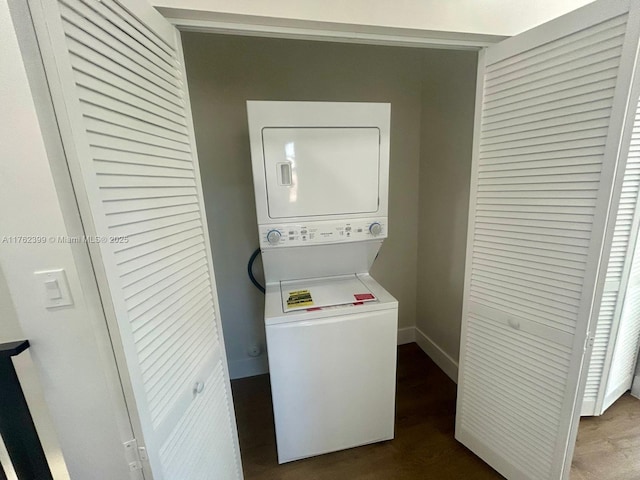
[{"xmin": 582, "ymin": 94, "xmax": 640, "ymax": 415}]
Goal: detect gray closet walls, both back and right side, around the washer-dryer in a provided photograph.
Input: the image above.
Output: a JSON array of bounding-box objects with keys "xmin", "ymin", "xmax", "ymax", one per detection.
[{"xmin": 183, "ymin": 33, "xmax": 476, "ymax": 376}]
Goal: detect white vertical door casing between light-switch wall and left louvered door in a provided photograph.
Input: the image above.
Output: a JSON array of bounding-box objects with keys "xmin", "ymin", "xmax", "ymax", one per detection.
[{"xmin": 8, "ymin": 0, "xmax": 145, "ymax": 479}]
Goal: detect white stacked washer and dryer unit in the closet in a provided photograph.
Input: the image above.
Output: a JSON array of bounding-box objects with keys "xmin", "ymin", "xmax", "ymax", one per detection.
[{"xmin": 247, "ymin": 101, "xmax": 398, "ymax": 463}]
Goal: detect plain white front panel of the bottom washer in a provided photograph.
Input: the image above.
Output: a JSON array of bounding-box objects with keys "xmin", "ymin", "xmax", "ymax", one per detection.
[{"xmin": 266, "ymin": 306, "xmax": 398, "ymax": 463}]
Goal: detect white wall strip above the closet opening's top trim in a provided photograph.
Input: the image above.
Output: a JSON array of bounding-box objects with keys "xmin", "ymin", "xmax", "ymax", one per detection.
[{"xmin": 150, "ymin": 0, "xmax": 593, "ymax": 36}]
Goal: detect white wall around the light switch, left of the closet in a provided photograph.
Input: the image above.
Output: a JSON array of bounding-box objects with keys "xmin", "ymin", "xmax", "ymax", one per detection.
[{"xmin": 0, "ymin": 0, "xmax": 132, "ymax": 480}]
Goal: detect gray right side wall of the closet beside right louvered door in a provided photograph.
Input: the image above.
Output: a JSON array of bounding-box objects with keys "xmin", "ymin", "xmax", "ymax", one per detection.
[{"xmin": 416, "ymin": 51, "xmax": 477, "ymax": 362}]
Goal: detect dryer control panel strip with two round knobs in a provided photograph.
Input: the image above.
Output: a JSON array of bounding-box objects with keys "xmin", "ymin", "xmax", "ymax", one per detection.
[{"xmin": 260, "ymin": 217, "xmax": 387, "ymax": 248}]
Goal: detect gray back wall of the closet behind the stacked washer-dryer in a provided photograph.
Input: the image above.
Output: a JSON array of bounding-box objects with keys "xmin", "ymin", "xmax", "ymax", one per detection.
[{"xmin": 183, "ymin": 33, "xmax": 423, "ymax": 375}]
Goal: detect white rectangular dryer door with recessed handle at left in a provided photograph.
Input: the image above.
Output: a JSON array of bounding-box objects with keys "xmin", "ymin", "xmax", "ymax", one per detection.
[{"xmin": 262, "ymin": 127, "xmax": 380, "ymax": 219}]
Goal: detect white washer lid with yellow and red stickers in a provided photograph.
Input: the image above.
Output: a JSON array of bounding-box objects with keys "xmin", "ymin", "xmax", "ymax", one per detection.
[{"xmin": 280, "ymin": 275, "xmax": 377, "ymax": 313}]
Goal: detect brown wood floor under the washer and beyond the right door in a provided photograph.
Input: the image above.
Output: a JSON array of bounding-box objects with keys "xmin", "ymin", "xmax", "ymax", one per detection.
[{"xmin": 232, "ymin": 344, "xmax": 640, "ymax": 480}]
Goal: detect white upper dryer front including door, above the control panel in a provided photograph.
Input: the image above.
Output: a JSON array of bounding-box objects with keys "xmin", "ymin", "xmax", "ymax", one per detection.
[{"xmin": 247, "ymin": 101, "xmax": 391, "ymax": 228}]
